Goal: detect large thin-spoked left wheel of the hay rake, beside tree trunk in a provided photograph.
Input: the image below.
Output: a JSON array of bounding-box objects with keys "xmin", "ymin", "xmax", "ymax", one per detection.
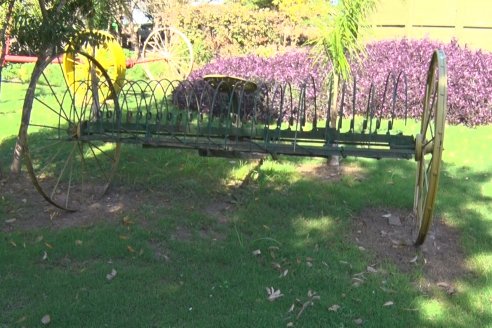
[{"xmin": 21, "ymin": 52, "xmax": 120, "ymax": 211}]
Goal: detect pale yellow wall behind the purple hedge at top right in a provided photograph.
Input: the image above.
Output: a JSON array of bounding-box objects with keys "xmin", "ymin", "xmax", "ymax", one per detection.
[{"xmin": 367, "ymin": 0, "xmax": 492, "ymax": 51}]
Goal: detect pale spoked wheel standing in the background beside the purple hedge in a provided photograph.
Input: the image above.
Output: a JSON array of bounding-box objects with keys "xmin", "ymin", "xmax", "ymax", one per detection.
[{"xmin": 142, "ymin": 27, "xmax": 193, "ymax": 80}]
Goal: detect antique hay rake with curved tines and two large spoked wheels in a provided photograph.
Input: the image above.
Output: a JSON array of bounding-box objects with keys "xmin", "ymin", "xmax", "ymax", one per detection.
[{"xmin": 21, "ymin": 51, "xmax": 447, "ymax": 245}]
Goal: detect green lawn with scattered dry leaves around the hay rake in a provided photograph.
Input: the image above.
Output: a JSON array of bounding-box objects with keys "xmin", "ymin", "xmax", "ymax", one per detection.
[{"xmin": 0, "ymin": 81, "xmax": 492, "ymax": 327}]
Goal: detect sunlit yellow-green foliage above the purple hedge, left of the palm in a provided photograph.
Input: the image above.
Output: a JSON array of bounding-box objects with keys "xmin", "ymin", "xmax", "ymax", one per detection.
[{"xmin": 158, "ymin": 4, "xmax": 308, "ymax": 63}]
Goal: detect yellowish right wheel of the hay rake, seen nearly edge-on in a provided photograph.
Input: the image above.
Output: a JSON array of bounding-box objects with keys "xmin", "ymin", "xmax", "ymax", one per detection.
[{"xmin": 414, "ymin": 50, "xmax": 447, "ymax": 246}]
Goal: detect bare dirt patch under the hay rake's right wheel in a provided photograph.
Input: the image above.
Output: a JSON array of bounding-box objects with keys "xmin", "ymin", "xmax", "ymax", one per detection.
[{"xmin": 352, "ymin": 208, "xmax": 471, "ymax": 294}]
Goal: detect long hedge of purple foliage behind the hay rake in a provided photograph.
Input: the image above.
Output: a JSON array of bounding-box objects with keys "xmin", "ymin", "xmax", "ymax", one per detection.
[{"xmin": 177, "ymin": 39, "xmax": 492, "ymax": 126}]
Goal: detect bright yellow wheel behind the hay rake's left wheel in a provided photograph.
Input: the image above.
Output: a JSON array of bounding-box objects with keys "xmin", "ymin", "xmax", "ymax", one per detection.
[{"xmin": 63, "ymin": 31, "xmax": 126, "ymax": 94}]
